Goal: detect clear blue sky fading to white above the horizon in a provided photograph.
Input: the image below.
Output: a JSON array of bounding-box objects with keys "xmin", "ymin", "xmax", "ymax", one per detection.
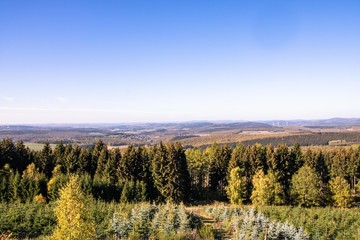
[{"xmin": 0, "ymin": 0, "xmax": 360, "ymax": 124}]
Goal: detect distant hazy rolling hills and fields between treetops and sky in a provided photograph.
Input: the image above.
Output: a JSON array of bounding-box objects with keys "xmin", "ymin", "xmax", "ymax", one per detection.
[{"xmin": 0, "ymin": 118, "xmax": 360, "ymax": 149}]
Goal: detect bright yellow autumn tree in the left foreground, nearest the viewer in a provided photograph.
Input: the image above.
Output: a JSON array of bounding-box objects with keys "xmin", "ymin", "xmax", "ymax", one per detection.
[{"xmin": 50, "ymin": 176, "xmax": 96, "ymax": 240}]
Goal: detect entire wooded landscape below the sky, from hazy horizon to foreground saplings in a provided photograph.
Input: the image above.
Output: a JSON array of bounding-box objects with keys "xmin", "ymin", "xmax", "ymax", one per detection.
[{"xmin": 0, "ymin": 118, "xmax": 360, "ymax": 239}]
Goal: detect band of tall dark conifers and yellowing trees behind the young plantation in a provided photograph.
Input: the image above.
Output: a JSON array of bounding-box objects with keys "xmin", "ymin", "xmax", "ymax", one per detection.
[{"xmin": 0, "ymin": 139, "xmax": 360, "ymax": 207}]
